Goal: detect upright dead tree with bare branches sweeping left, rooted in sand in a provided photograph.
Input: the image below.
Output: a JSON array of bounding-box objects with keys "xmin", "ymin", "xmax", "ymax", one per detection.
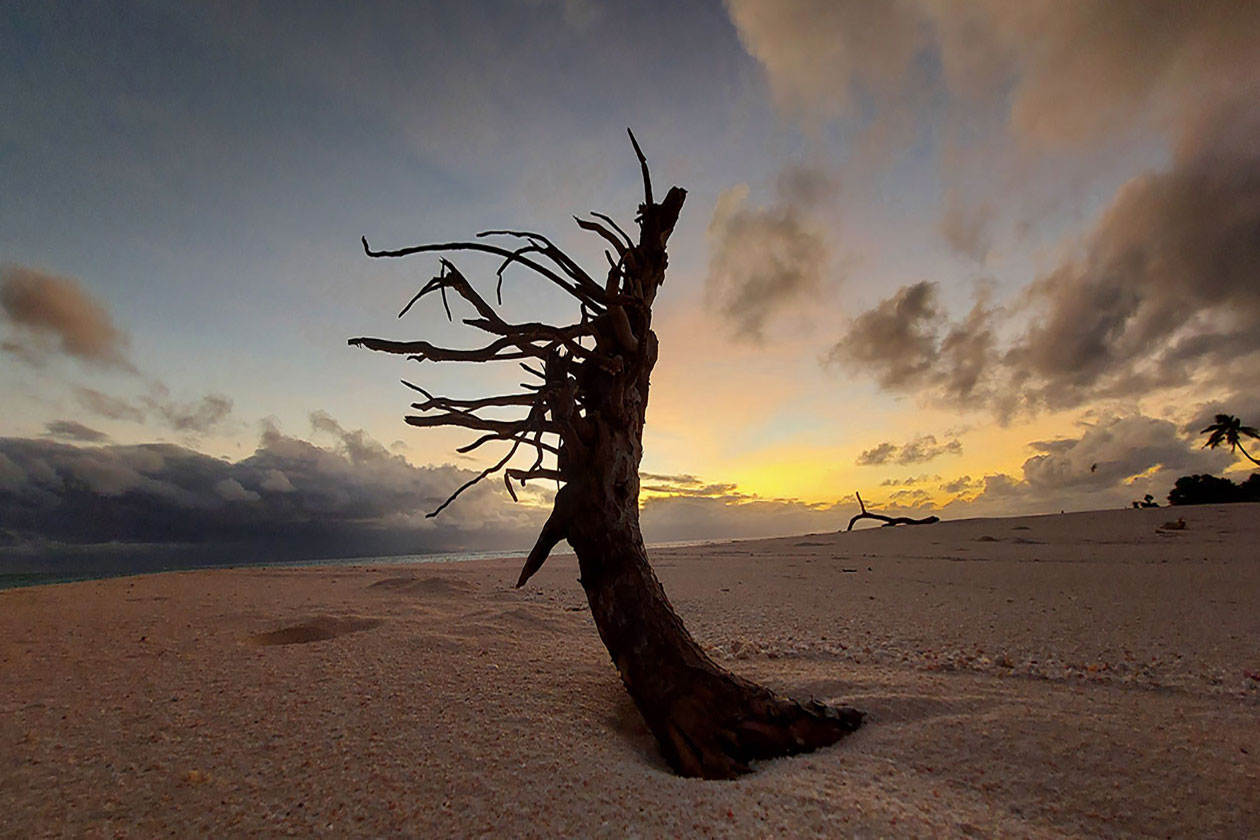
[{"xmin": 350, "ymin": 133, "xmax": 862, "ymax": 778}]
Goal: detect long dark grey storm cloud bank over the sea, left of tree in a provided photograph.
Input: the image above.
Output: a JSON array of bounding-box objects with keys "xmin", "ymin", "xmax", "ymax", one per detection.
[{"xmin": 0, "ymin": 418, "xmax": 544, "ymax": 569}]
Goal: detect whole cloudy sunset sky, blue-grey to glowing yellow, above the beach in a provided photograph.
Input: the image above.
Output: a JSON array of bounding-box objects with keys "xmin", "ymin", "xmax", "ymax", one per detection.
[{"xmin": 0, "ymin": 0, "xmax": 1260, "ymax": 565}]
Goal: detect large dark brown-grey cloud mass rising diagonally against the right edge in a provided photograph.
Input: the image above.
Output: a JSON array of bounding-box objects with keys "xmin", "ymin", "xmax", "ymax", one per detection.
[{"xmin": 1005, "ymin": 95, "xmax": 1260, "ymax": 407}]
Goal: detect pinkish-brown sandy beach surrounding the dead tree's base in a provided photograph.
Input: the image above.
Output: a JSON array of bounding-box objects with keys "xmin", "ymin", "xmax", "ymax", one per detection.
[{"xmin": 0, "ymin": 505, "xmax": 1260, "ymax": 837}]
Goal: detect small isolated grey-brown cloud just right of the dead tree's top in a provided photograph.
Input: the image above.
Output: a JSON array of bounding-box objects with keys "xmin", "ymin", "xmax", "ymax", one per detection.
[{"xmin": 706, "ymin": 167, "xmax": 835, "ymax": 343}]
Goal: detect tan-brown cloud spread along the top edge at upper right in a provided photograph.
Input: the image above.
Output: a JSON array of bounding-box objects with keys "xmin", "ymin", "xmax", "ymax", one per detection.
[{"xmin": 726, "ymin": 0, "xmax": 1260, "ymax": 149}]
